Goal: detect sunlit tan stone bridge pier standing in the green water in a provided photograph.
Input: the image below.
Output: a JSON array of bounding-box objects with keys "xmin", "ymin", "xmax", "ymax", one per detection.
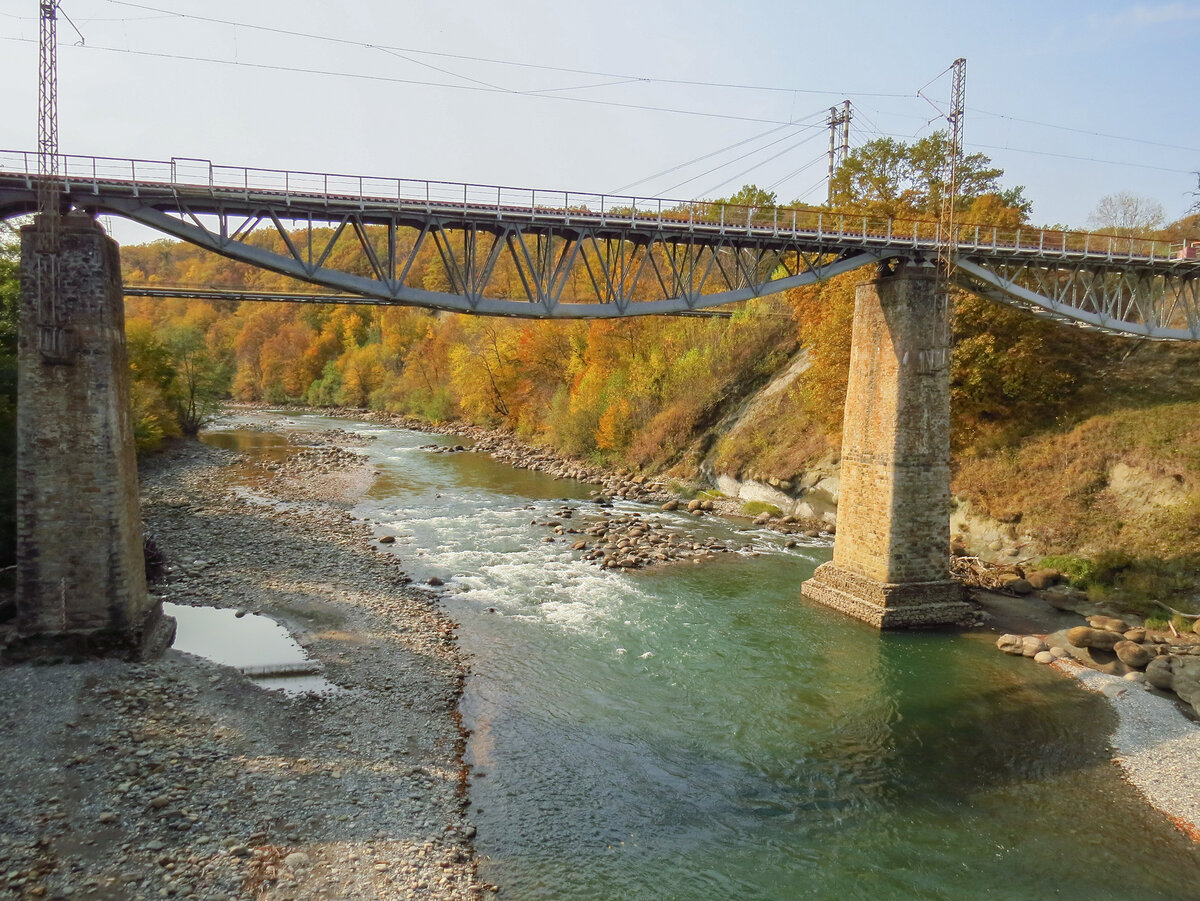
[{"xmin": 802, "ymin": 265, "xmax": 970, "ymax": 629}]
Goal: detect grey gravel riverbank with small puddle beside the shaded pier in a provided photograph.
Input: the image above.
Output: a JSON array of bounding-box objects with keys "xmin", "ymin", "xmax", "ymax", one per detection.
[{"xmin": 0, "ymin": 436, "xmax": 491, "ymax": 901}]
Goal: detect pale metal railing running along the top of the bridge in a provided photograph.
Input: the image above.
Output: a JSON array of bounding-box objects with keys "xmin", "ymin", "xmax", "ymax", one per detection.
[{"xmin": 0, "ymin": 150, "xmax": 1180, "ymax": 262}]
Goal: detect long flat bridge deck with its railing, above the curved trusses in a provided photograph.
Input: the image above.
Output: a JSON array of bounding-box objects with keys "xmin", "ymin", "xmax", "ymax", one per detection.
[{"xmin": 0, "ymin": 150, "xmax": 1200, "ymax": 271}]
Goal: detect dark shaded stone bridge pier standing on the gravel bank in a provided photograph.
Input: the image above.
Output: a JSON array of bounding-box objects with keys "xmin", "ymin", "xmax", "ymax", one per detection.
[{"xmin": 5, "ymin": 214, "xmax": 175, "ymax": 660}]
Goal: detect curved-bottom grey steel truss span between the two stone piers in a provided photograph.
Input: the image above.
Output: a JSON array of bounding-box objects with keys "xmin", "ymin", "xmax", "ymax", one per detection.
[{"xmin": 82, "ymin": 198, "xmax": 883, "ymax": 319}]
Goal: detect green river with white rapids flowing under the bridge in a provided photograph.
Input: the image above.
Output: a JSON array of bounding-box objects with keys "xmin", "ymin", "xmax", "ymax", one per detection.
[{"xmin": 209, "ymin": 415, "xmax": 1200, "ymax": 901}]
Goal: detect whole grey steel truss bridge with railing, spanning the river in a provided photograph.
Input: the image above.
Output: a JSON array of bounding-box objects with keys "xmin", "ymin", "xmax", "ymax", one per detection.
[{"xmin": 0, "ymin": 150, "xmax": 1200, "ymax": 341}]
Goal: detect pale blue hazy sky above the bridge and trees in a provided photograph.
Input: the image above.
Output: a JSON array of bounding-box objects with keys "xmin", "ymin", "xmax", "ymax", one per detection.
[{"xmin": 0, "ymin": 0, "xmax": 1200, "ymax": 240}]
